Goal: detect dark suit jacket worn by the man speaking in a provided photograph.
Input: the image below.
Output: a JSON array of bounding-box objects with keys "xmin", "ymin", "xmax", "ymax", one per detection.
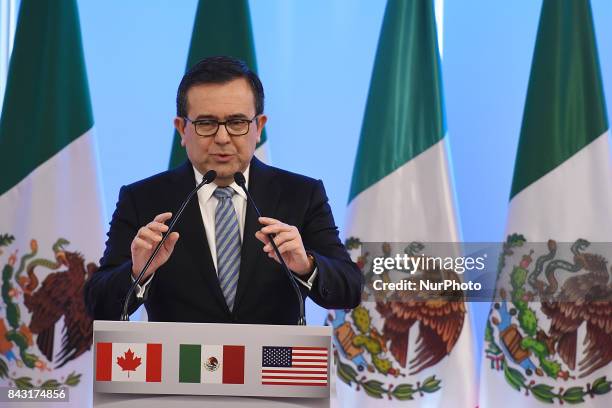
[{"xmin": 85, "ymin": 158, "xmax": 363, "ymax": 324}]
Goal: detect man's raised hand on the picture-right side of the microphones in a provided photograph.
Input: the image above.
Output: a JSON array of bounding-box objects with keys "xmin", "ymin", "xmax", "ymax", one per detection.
[{"xmin": 255, "ymin": 217, "xmax": 314, "ymax": 277}]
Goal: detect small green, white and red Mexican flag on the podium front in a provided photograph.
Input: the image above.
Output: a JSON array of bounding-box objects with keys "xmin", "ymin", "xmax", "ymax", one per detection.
[{"xmin": 179, "ymin": 344, "xmax": 244, "ymax": 384}]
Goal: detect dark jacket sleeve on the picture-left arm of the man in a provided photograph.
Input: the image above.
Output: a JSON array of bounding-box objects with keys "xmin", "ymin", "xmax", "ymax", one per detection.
[{"xmin": 84, "ymin": 186, "xmax": 140, "ymax": 320}]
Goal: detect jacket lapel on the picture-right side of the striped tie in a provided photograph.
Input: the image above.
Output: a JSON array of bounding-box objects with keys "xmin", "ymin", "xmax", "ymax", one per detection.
[{"xmin": 234, "ymin": 157, "xmax": 280, "ymax": 310}]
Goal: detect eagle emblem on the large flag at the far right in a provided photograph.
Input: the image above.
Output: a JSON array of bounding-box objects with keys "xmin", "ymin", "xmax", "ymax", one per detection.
[{"xmin": 485, "ymin": 234, "xmax": 612, "ymax": 404}]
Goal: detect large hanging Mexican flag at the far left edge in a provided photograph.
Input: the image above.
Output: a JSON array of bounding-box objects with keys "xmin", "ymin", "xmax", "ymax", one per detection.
[{"xmin": 0, "ymin": 0, "xmax": 104, "ymax": 407}]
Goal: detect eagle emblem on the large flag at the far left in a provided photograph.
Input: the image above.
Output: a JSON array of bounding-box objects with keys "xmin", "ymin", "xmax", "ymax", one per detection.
[{"xmin": 0, "ymin": 234, "xmax": 97, "ymax": 388}]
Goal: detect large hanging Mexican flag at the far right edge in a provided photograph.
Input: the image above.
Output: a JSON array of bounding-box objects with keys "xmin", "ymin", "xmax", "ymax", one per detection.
[{"xmin": 480, "ymin": 0, "xmax": 612, "ymax": 407}]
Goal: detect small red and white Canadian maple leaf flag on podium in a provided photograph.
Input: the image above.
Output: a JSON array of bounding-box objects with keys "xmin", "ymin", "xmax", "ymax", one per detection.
[{"xmin": 96, "ymin": 343, "xmax": 162, "ymax": 382}]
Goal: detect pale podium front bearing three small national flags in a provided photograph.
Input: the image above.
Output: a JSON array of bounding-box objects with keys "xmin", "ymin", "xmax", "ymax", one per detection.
[{"xmin": 93, "ymin": 321, "xmax": 332, "ymax": 408}]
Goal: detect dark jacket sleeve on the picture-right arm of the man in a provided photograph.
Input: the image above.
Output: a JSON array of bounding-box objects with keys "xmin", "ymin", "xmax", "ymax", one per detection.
[{"xmin": 302, "ymin": 180, "xmax": 363, "ymax": 309}]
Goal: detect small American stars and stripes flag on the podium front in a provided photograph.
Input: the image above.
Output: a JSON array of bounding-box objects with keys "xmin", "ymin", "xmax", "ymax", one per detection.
[{"xmin": 261, "ymin": 346, "xmax": 329, "ymax": 387}]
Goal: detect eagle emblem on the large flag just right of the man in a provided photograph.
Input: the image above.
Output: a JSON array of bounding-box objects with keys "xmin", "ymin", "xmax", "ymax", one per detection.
[{"xmin": 328, "ymin": 237, "xmax": 466, "ymax": 400}]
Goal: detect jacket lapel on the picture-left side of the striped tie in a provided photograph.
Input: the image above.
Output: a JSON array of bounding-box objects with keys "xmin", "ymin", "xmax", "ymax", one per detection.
[{"xmin": 175, "ymin": 161, "xmax": 230, "ymax": 314}]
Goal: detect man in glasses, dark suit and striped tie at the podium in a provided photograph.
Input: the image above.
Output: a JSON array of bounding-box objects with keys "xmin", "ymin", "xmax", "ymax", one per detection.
[{"xmin": 85, "ymin": 57, "xmax": 363, "ymax": 324}]
